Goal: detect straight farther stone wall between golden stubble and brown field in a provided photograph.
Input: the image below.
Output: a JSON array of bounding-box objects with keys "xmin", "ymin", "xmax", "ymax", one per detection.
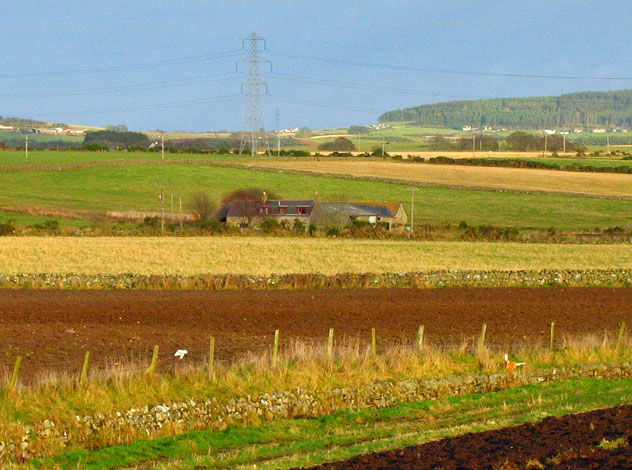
[{"xmin": 0, "ymin": 269, "xmax": 632, "ymax": 290}]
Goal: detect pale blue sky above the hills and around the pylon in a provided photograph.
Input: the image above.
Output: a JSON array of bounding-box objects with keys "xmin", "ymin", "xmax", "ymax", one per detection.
[{"xmin": 0, "ymin": 0, "xmax": 632, "ymax": 131}]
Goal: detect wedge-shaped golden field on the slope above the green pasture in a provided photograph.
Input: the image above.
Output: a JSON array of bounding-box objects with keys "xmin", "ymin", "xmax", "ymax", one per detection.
[{"xmin": 242, "ymin": 159, "xmax": 632, "ymax": 197}]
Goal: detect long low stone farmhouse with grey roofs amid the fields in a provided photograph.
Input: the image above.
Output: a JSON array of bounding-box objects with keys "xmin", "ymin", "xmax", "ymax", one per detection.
[{"xmin": 220, "ymin": 193, "xmax": 408, "ymax": 230}]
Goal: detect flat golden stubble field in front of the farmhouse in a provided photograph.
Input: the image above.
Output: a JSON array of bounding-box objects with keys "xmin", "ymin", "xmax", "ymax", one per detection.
[{"xmin": 0, "ymin": 237, "xmax": 632, "ymax": 275}]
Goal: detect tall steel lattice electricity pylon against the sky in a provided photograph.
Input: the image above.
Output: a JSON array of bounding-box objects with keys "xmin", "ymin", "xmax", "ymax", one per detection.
[{"xmin": 236, "ymin": 33, "xmax": 272, "ymax": 156}]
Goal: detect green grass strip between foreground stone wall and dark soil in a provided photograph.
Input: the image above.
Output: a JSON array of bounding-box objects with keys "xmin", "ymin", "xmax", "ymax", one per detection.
[{"xmin": 28, "ymin": 379, "xmax": 632, "ymax": 470}]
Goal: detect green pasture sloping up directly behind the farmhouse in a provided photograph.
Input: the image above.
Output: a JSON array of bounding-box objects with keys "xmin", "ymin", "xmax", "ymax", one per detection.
[{"xmin": 0, "ymin": 162, "xmax": 632, "ymax": 229}]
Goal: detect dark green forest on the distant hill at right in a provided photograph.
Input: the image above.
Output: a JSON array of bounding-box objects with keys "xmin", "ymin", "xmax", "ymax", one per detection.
[{"xmin": 379, "ymin": 90, "xmax": 632, "ymax": 129}]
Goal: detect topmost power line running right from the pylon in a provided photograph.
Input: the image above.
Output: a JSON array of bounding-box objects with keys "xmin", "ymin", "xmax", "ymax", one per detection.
[{"xmin": 269, "ymin": 52, "xmax": 632, "ymax": 80}]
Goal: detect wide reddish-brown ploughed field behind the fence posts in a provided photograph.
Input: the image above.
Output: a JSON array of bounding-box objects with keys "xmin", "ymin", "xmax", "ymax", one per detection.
[{"xmin": 0, "ymin": 288, "xmax": 632, "ymax": 377}]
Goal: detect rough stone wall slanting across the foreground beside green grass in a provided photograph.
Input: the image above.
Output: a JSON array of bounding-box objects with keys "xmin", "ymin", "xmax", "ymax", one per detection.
[{"xmin": 0, "ymin": 362, "xmax": 632, "ymax": 464}]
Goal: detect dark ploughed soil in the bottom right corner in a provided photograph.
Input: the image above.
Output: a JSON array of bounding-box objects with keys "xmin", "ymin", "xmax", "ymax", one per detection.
[{"xmin": 298, "ymin": 405, "xmax": 632, "ymax": 470}]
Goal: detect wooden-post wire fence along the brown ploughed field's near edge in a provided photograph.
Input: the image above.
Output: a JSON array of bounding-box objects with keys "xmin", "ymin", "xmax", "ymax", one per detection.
[{"xmin": 1, "ymin": 323, "xmax": 625, "ymax": 388}]
